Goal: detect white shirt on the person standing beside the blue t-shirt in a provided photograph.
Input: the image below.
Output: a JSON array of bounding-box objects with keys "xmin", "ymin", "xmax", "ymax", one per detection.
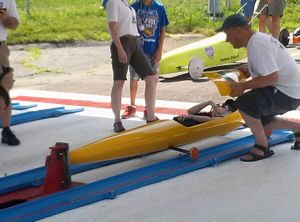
[{"xmin": 106, "ymin": 0, "xmax": 139, "ymax": 37}]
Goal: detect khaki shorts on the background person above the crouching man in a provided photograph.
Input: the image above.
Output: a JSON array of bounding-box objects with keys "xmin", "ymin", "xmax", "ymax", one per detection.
[{"xmin": 255, "ymin": 0, "xmax": 286, "ymax": 17}]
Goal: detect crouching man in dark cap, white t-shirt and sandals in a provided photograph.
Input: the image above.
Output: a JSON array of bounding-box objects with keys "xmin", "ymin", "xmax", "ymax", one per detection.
[{"xmin": 218, "ymin": 14, "xmax": 300, "ymax": 161}]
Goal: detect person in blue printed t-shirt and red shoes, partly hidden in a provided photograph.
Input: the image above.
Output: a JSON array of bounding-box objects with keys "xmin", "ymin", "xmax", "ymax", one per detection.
[{"xmin": 122, "ymin": 0, "xmax": 169, "ymax": 119}]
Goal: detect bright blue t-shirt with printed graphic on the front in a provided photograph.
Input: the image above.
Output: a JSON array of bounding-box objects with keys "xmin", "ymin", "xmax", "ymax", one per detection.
[{"xmin": 132, "ymin": 0, "xmax": 169, "ymax": 56}]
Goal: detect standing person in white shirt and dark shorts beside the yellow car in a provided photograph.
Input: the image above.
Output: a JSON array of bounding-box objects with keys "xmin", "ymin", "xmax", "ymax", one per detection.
[{"xmin": 104, "ymin": 0, "xmax": 158, "ymax": 132}]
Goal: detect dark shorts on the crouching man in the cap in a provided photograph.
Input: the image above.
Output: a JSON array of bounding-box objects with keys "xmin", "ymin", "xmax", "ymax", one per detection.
[{"xmin": 235, "ymin": 86, "xmax": 300, "ymax": 125}]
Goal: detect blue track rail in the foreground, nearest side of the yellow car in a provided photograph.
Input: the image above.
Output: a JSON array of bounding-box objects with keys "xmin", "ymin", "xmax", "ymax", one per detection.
[{"xmin": 0, "ymin": 131, "xmax": 293, "ymax": 222}]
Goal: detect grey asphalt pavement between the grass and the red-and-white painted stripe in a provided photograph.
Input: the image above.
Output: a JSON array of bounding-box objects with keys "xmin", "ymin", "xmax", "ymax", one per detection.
[{"xmin": 11, "ymin": 36, "xmax": 300, "ymax": 102}]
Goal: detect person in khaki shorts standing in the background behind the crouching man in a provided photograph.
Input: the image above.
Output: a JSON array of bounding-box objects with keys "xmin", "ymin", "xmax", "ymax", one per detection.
[{"xmin": 255, "ymin": 0, "xmax": 286, "ymax": 39}]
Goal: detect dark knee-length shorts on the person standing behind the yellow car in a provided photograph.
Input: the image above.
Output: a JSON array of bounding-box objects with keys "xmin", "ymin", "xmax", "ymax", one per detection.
[{"xmin": 110, "ymin": 36, "xmax": 156, "ymax": 80}]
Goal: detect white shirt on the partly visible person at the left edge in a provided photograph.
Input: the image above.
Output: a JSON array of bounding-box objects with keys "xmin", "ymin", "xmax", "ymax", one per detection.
[{"xmin": 0, "ymin": 0, "xmax": 19, "ymax": 41}]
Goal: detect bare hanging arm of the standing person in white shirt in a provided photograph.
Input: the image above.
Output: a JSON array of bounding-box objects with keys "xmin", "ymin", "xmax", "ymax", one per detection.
[{"xmin": 108, "ymin": 22, "xmax": 128, "ymax": 64}]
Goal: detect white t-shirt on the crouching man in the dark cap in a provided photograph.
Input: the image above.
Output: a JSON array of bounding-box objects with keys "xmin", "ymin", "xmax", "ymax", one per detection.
[{"xmin": 247, "ymin": 32, "xmax": 300, "ymax": 99}]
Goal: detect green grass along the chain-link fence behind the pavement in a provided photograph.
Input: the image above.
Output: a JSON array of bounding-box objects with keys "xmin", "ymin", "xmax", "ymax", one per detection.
[{"xmin": 9, "ymin": 0, "xmax": 300, "ymax": 44}]
